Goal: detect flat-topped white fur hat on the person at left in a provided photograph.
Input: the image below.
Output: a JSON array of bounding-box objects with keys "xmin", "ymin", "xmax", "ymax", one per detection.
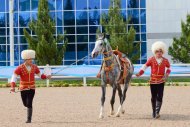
[{"xmin": 21, "ymin": 50, "xmax": 36, "ymax": 59}]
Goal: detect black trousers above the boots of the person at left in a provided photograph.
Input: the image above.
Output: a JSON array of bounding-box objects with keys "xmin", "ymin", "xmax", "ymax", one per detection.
[{"xmin": 21, "ymin": 89, "xmax": 35, "ymax": 108}]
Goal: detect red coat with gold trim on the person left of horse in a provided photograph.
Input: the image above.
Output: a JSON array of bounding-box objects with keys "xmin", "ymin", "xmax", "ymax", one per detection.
[{"xmin": 14, "ymin": 64, "xmax": 40, "ymax": 90}]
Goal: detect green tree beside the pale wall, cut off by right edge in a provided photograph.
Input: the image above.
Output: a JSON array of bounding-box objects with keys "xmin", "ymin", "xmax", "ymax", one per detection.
[{"xmin": 168, "ymin": 14, "xmax": 190, "ymax": 63}]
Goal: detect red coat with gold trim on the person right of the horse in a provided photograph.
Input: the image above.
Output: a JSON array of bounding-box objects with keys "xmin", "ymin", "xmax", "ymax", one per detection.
[{"xmin": 140, "ymin": 57, "xmax": 171, "ymax": 84}]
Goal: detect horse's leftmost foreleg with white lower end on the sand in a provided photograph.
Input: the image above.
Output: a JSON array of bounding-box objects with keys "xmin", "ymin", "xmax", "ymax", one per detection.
[{"xmin": 99, "ymin": 85, "xmax": 106, "ymax": 119}]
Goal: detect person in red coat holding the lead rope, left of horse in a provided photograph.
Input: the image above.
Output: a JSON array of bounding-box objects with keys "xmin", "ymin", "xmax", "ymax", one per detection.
[{"xmin": 11, "ymin": 50, "xmax": 51, "ymax": 123}]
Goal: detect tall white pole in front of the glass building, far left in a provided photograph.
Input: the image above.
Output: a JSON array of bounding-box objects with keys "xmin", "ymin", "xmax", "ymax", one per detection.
[{"xmin": 9, "ymin": 0, "xmax": 14, "ymax": 66}]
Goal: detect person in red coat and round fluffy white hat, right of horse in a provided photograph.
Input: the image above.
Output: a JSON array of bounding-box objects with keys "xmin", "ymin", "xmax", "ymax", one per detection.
[{"xmin": 136, "ymin": 41, "xmax": 171, "ymax": 118}]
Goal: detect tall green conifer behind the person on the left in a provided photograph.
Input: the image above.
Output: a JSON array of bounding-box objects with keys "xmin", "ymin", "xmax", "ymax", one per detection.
[{"xmin": 24, "ymin": 0, "xmax": 67, "ymax": 65}]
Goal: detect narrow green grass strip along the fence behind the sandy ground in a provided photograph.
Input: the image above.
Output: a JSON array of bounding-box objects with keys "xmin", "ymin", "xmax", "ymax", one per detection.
[{"xmin": 0, "ymin": 78, "xmax": 190, "ymax": 88}]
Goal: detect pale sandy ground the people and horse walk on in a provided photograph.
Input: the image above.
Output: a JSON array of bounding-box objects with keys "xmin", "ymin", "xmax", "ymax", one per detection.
[{"xmin": 0, "ymin": 86, "xmax": 190, "ymax": 127}]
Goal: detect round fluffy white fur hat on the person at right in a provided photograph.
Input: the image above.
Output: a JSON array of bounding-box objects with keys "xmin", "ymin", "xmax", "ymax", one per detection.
[{"xmin": 152, "ymin": 41, "xmax": 166, "ymax": 54}]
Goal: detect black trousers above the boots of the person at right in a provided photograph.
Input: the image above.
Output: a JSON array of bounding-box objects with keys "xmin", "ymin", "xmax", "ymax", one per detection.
[{"xmin": 150, "ymin": 83, "xmax": 164, "ymax": 102}]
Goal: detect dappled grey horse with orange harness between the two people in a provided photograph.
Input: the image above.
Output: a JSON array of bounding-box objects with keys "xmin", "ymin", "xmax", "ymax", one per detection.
[{"xmin": 91, "ymin": 34, "xmax": 134, "ymax": 119}]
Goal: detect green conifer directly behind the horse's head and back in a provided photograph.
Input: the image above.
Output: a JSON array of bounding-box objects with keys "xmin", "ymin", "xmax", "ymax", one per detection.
[{"xmin": 100, "ymin": 0, "xmax": 140, "ymax": 63}]
